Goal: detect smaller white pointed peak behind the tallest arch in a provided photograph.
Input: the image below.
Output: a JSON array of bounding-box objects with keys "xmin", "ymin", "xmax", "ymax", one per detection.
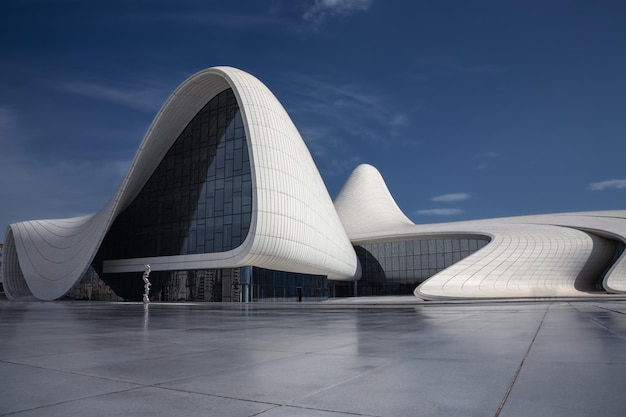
[{"xmin": 334, "ymin": 164, "xmax": 414, "ymax": 240}]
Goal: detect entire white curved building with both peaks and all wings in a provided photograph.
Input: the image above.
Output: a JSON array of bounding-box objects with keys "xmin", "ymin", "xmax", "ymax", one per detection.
[{"xmin": 2, "ymin": 67, "xmax": 626, "ymax": 301}]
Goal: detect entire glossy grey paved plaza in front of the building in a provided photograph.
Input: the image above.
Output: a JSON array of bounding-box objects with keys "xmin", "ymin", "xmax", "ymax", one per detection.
[{"xmin": 0, "ymin": 297, "xmax": 626, "ymax": 417}]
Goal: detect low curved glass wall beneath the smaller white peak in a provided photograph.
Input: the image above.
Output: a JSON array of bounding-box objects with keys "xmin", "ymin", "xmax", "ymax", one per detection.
[{"xmin": 331, "ymin": 236, "xmax": 490, "ymax": 296}]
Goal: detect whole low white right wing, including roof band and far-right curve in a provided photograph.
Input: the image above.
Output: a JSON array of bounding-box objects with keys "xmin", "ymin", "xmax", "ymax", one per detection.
[{"xmin": 408, "ymin": 211, "xmax": 626, "ymax": 299}]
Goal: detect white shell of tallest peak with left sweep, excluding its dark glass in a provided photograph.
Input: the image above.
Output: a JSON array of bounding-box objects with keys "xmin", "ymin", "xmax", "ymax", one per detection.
[{"xmin": 3, "ymin": 67, "xmax": 359, "ymax": 300}]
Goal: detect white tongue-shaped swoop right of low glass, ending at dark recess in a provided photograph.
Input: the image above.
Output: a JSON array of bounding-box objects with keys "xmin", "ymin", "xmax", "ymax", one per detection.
[{"xmin": 415, "ymin": 220, "xmax": 615, "ymax": 299}]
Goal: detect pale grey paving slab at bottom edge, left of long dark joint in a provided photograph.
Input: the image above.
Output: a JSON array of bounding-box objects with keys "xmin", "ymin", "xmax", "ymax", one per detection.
[{"xmin": 294, "ymin": 359, "xmax": 517, "ymax": 417}]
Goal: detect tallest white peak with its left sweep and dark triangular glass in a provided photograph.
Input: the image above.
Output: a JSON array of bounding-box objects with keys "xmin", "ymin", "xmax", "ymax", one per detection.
[{"xmin": 3, "ymin": 67, "xmax": 359, "ymax": 300}]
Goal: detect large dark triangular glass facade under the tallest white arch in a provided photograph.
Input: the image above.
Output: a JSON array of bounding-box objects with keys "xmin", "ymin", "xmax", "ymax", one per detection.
[{"xmin": 94, "ymin": 89, "xmax": 252, "ymax": 264}]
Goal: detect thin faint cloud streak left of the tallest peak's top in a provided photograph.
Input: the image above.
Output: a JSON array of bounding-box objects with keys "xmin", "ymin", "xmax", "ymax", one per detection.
[{"xmin": 52, "ymin": 81, "xmax": 169, "ymax": 111}]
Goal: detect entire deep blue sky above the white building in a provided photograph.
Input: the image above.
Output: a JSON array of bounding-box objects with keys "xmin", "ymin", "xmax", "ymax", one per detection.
[{"xmin": 0, "ymin": 0, "xmax": 626, "ymax": 236}]
